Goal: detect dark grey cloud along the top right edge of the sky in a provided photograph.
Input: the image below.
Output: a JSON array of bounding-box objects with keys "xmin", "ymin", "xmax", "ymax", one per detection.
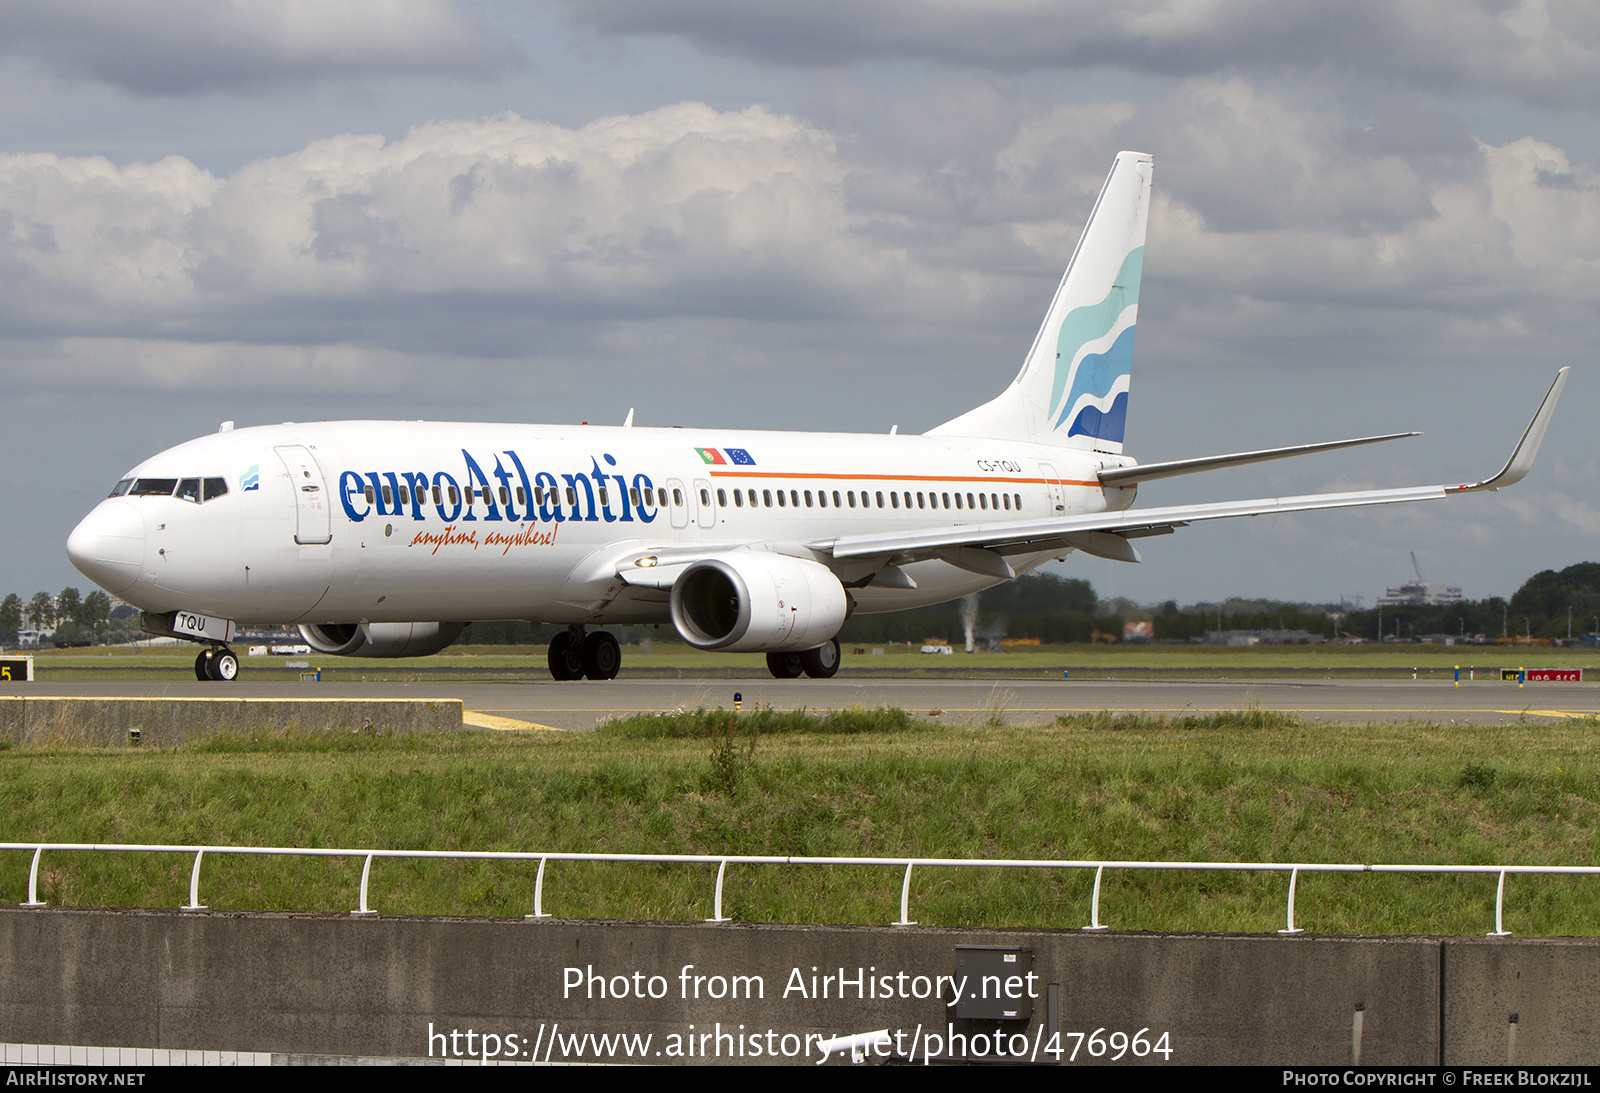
[{"xmin": 554, "ymin": 0, "xmax": 1600, "ymax": 107}]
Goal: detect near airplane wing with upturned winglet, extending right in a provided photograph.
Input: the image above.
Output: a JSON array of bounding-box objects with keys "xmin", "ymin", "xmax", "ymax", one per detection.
[{"xmin": 810, "ymin": 368, "xmax": 1570, "ymax": 578}]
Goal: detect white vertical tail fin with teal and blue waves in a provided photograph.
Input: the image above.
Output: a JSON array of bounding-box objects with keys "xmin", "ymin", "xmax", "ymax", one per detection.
[{"xmin": 930, "ymin": 152, "xmax": 1154, "ymax": 453}]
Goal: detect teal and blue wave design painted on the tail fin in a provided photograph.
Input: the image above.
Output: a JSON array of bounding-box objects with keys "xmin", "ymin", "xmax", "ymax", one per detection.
[{"xmin": 1050, "ymin": 246, "xmax": 1144, "ymax": 443}]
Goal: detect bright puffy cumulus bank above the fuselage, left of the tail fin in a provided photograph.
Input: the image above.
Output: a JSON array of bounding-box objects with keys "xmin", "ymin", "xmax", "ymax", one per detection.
[{"xmin": 0, "ymin": 104, "xmax": 947, "ymax": 377}]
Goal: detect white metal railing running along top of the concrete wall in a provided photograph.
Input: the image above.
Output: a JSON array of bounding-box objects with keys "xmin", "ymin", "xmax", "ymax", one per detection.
[{"xmin": 0, "ymin": 842, "xmax": 1600, "ymax": 938}]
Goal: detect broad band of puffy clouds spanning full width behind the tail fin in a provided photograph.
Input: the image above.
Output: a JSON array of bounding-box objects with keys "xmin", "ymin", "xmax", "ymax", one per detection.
[{"xmin": 0, "ymin": 80, "xmax": 1600, "ymax": 397}]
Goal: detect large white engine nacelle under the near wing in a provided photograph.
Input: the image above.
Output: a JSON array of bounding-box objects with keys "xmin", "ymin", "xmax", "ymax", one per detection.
[{"xmin": 672, "ymin": 551, "xmax": 850, "ymax": 653}]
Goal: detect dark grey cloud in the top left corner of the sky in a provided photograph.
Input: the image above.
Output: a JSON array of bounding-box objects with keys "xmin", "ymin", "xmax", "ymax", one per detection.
[{"xmin": 0, "ymin": 0, "xmax": 515, "ymax": 94}]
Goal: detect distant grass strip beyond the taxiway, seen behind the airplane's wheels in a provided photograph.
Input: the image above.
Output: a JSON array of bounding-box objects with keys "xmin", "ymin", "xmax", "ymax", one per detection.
[{"xmin": 34, "ymin": 642, "xmax": 1600, "ymax": 682}]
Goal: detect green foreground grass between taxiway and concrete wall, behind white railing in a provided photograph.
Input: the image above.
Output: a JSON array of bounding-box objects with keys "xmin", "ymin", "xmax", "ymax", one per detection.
[{"xmin": 0, "ymin": 711, "xmax": 1600, "ymax": 936}]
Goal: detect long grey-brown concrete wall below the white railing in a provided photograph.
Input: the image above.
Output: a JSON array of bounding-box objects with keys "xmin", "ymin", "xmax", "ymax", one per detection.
[{"xmin": 0, "ymin": 909, "xmax": 1600, "ymax": 1066}]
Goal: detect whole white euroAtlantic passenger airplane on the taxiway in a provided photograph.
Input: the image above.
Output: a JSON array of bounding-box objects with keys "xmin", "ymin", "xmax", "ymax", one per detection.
[{"xmin": 67, "ymin": 152, "xmax": 1566, "ymax": 680}]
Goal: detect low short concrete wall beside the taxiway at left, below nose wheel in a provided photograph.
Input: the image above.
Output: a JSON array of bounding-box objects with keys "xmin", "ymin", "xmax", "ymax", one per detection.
[{"xmin": 0, "ymin": 695, "xmax": 461, "ymax": 747}]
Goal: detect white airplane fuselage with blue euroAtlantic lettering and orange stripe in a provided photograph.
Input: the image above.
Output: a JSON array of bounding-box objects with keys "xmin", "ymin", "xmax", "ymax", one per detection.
[{"xmin": 69, "ymin": 421, "xmax": 1134, "ymax": 624}]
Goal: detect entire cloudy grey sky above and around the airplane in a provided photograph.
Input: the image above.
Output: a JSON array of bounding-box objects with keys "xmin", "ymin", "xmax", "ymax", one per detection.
[{"xmin": 0, "ymin": 0, "xmax": 1600, "ymax": 605}]
